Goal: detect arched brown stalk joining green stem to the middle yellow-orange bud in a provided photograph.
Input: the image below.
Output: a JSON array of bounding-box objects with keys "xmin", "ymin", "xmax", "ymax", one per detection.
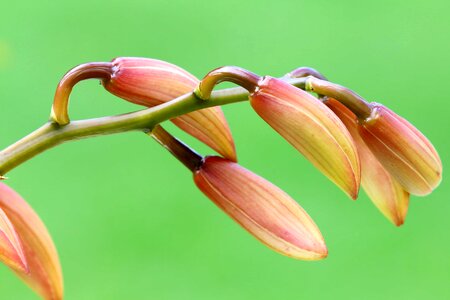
[{"xmin": 194, "ymin": 66, "xmax": 261, "ymax": 100}]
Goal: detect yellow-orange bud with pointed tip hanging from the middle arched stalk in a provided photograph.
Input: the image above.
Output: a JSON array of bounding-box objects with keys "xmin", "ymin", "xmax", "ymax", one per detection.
[{"xmin": 250, "ymin": 77, "xmax": 360, "ymax": 199}]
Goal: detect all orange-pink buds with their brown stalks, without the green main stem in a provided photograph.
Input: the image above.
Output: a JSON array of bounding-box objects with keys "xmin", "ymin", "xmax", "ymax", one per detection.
[{"xmin": 0, "ymin": 58, "xmax": 442, "ymax": 299}]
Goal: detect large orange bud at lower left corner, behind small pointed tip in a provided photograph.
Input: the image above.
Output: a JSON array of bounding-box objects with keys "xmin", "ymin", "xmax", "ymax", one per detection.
[{"xmin": 0, "ymin": 182, "xmax": 63, "ymax": 300}]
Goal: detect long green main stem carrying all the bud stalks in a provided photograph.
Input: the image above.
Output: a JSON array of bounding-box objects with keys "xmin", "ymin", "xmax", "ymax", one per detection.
[{"xmin": 0, "ymin": 78, "xmax": 306, "ymax": 176}]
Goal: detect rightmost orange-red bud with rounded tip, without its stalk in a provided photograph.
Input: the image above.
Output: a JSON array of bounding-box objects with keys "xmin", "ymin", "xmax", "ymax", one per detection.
[{"xmin": 359, "ymin": 103, "xmax": 442, "ymax": 195}]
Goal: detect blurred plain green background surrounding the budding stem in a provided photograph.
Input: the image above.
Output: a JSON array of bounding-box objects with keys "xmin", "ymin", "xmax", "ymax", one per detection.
[{"xmin": 0, "ymin": 0, "xmax": 450, "ymax": 300}]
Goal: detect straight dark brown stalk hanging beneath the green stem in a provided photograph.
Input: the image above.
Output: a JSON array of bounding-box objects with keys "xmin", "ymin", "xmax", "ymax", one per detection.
[{"xmin": 148, "ymin": 125, "xmax": 203, "ymax": 172}]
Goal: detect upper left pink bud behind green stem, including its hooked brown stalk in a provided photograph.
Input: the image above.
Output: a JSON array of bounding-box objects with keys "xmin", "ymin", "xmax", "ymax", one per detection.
[{"xmin": 52, "ymin": 57, "xmax": 236, "ymax": 161}]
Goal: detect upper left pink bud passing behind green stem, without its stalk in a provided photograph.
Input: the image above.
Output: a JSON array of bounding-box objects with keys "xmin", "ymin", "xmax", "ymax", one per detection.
[{"xmin": 103, "ymin": 57, "xmax": 236, "ymax": 161}]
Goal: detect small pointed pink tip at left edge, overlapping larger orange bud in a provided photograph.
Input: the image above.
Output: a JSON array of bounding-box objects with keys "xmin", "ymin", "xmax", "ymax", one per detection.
[{"xmin": 0, "ymin": 208, "xmax": 28, "ymax": 273}]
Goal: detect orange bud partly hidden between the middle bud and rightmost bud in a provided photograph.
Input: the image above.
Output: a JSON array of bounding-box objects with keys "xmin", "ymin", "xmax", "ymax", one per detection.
[{"xmin": 325, "ymin": 98, "xmax": 409, "ymax": 226}]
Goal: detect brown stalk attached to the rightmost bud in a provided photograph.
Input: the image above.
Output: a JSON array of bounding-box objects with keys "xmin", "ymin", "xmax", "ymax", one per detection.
[{"xmin": 305, "ymin": 76, "xmax": 372, "ymax": 119}]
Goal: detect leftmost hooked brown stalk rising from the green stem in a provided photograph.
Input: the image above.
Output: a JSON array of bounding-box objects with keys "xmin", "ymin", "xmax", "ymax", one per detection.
[{"xmin": 50, "ymin": 62, "xmax": 113, "ymax": 125}]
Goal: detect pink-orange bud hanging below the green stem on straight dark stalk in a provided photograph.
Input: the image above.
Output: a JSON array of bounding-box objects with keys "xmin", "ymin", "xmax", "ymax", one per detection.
[{"xmin": 194, "ymin": 157, "xmax": 327, "ymax": 260}]
